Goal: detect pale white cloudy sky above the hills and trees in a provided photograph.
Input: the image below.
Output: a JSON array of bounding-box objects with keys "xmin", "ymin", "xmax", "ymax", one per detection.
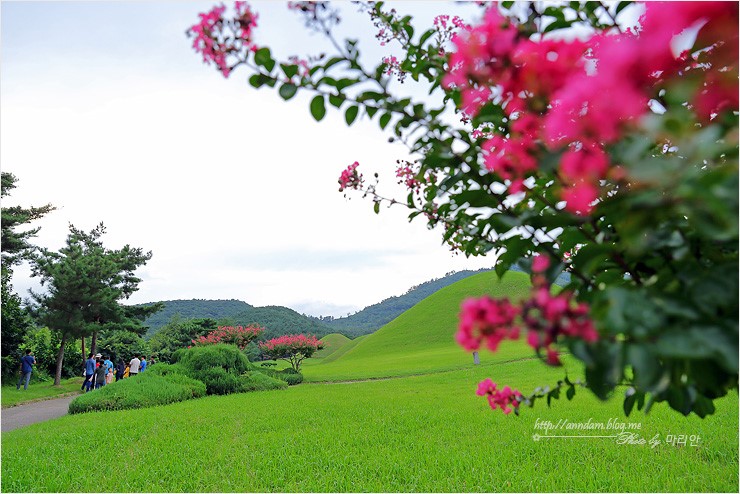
[{"xmin": 0, "ymin": 1, "xmax": 493, "ymax": 315}]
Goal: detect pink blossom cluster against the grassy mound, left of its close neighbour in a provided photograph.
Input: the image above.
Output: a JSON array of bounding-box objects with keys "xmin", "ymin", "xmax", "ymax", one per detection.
[{"xmin": 455, "ymin": 296, "xmax": 519, "ymax": 352}]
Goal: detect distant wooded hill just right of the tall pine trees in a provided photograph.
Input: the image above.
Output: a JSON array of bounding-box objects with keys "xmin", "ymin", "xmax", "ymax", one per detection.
[{"xmin": 141, "ymin": 299, "xmax": 252, "ymax": 339}]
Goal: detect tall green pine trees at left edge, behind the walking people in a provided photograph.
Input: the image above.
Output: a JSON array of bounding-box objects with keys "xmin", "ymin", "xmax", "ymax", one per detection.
[{"xmin": 2, "ymin": 172, "xmax": 162, "ymax": 385}]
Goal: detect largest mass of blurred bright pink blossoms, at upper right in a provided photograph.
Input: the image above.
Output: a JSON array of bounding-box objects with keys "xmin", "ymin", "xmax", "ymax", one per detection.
[{"xmin": 440, "ymin": 2, "xmax": 738, "ymax": 215}]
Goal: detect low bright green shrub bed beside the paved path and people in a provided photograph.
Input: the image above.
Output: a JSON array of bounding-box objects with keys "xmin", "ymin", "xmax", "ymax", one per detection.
[{"xmin": 69, "ymin": 371, "xmax": 206, "ymax": 414}]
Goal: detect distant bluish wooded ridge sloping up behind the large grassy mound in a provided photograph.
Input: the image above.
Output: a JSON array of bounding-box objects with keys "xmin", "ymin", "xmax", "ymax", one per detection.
[{"xmin": 317, "ymin": 269, "xmax": 490, "ymax": 338}]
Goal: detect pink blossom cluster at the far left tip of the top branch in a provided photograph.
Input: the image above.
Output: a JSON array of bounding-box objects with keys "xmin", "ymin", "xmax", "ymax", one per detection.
[{"xmin": 188, "ymin": 1, "xmax": 257, "ymax": 77}]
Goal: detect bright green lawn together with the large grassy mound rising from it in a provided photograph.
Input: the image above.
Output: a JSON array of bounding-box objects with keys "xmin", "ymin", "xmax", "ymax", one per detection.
[{"xmin": 2, "ymin": 273, "xmax": 738, "ymax": 492}]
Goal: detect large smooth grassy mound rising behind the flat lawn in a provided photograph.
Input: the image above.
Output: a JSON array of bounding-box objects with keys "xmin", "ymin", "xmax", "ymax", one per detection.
[{"xmin": 304, "ymin": 271, "xmax": 532, "ymax": 381}]
